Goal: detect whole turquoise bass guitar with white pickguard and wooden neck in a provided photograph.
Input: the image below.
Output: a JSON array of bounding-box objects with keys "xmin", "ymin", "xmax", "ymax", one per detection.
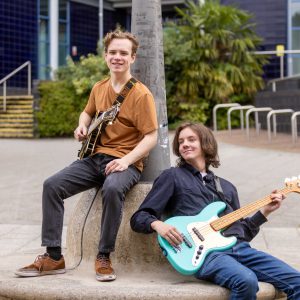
[{"xmin": 158, "ymin": 176, "xmax": 300, "ymax": 275}]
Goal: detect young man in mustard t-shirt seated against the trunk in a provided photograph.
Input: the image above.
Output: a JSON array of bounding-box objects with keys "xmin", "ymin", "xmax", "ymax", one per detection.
[{"xmin": 15, "ymin": 30, "xmax": 157, "ymax": 281}]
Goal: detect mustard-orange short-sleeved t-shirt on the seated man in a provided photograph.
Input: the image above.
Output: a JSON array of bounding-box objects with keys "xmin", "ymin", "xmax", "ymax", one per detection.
[{"xmin": 84, "ymin": 78, "xmax": 158, "ymax": 171}]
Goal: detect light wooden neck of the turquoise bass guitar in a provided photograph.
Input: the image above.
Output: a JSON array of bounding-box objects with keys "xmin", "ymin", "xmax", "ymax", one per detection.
[{"xmin": 210, "ymin": 188, "xmax": 291, "ymax": 231}]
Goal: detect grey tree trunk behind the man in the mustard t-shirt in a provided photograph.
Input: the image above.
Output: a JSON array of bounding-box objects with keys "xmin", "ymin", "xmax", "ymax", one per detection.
[{"xmin": 131, "ymin": 0, "xmax": 170, "ymax": 181}]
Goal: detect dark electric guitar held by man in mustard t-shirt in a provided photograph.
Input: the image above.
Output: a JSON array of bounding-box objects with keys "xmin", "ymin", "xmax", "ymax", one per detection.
[{"xmin": 78, "ymin": 103, "xmax": 120, "ymax": 159}]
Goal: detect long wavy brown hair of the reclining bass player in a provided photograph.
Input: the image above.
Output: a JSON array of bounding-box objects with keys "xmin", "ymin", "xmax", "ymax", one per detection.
[{"xmin": 173, "ymin": 122, "xmax": 220, "ymax": 170}]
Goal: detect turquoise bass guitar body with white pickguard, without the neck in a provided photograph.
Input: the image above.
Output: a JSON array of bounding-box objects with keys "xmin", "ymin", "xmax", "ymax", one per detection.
[{"xmin": 158, "ymin": 201, "xmax": 237, "ymax": 275}]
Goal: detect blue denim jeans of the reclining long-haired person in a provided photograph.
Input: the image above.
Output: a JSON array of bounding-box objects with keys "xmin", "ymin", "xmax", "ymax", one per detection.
[{"xmin": 196, "ymin": 242, "xmax": 300, "ymax": 300}]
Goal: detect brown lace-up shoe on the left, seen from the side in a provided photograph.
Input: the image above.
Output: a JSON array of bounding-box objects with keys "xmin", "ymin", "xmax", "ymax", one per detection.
[{"xmin": 15, "ymin": 253, "xmax": 66, "ymax": 277}]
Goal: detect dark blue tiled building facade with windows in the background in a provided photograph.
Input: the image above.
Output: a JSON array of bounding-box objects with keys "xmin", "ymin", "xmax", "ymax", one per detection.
[{"xmin": 0, "ymin": 0, "xmax": 300, "ymax": 86}]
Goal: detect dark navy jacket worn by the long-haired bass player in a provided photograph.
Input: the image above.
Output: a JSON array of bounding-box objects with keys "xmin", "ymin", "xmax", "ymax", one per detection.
[{"xmin": 130, "ymin": 164, "xmax": 267, "ymax": 241}]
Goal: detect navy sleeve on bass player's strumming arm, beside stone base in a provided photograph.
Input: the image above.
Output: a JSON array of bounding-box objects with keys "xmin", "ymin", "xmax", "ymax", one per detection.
[{"xmin": 130, "ymin": 168, "xmax": 175, "ymax": 233}]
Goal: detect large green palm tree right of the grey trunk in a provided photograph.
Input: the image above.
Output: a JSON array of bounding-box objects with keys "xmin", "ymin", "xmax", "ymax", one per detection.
[{"xmin": 165, "ymin": 0, "xmax": 266, "ymax": 126}]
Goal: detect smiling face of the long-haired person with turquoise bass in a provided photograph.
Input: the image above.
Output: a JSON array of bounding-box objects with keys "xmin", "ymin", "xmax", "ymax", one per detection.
[{"xmin": 178, "ymin": 127, "xmax": 205, "ymax": 166}]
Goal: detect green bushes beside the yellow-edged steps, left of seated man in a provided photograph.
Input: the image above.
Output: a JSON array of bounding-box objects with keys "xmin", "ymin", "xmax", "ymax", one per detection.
[{"xmin": 36, "ymin": 54, "xmax": 108, "ymax": 137}]
